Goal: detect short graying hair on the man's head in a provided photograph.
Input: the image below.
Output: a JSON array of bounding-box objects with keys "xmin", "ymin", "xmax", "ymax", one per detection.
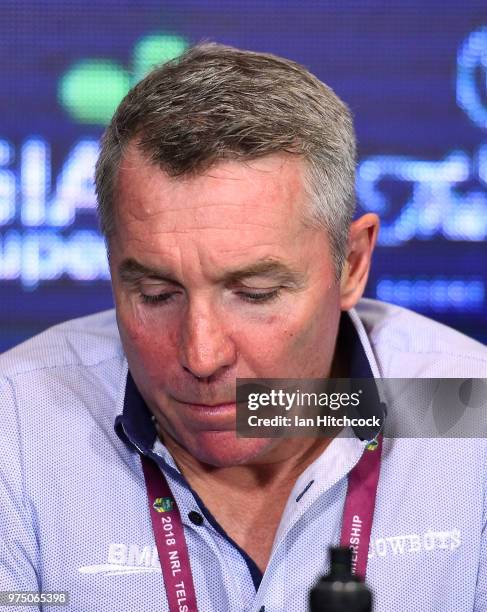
[{"xmin": 95, "ymin": 43, "xmax": 355, "ymax": 278}]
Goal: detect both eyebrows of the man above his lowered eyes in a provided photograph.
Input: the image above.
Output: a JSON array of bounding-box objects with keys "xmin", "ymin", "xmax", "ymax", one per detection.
[{"xmin": 118, "ymin": 258, "xmax": 305, "ymax": 288}]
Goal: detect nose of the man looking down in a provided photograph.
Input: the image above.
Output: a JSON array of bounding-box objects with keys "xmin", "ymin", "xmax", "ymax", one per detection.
[{"xmin": 181, "ymin": 302, "xmax": 236, "ymax": 379}]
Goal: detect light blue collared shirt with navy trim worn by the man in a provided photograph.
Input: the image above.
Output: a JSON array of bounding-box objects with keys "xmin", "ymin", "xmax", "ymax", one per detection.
[{"xmin": 0, "ymin": 300, "xmax": 487, "ymax": 612}]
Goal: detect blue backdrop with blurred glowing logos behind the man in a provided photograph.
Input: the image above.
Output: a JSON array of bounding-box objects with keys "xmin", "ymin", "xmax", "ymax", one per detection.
[{"xmin": 0, "ymin": 0, "xmax": 487, "ymax": 352}]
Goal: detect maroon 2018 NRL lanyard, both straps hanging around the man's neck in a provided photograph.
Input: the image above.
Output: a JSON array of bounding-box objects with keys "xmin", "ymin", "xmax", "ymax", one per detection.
[{"xmin": 142, "ymin": 436, "xmax": 382, "ymax": 612}]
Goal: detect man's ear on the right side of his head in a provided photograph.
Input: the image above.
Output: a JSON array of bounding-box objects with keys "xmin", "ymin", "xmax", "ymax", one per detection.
[{"xmin": 340, "ymin": 213, "xmax": 380, "ymax": 310}]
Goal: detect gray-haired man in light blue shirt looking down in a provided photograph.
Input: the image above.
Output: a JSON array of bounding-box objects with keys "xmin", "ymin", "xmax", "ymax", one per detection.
[{"xmin": 0, "ymin": 45, "xmax": 487, "ymax": 612}]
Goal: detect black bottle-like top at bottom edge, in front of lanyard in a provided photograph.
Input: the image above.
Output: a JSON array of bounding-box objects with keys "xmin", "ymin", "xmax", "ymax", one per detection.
[{"xmin": 309, "ymin": 547, "xmax": 372, "ymax": 612}]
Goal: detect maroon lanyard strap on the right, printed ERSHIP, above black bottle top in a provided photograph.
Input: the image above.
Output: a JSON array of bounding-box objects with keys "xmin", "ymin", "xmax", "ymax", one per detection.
[{"xmin": 340, "ymin": 435, "xmax": 382, "ymax": 579}]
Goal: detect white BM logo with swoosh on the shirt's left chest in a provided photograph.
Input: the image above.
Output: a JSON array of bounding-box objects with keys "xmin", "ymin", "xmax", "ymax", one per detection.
[{"xmin": 79, "ymin": 544, "xmax": 164, "ymax": 576}]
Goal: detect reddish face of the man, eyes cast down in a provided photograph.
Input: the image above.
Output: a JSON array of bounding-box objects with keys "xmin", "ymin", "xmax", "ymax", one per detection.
[{"xmin": 110, "ymin": 146, "xmax": 346, "ymax": 466}]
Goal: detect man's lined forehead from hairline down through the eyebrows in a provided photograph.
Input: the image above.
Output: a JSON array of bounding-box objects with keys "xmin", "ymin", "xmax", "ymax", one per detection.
[{"xmin": 110, "ymin": 147, "xmax": 328, "ymax": 275}]
